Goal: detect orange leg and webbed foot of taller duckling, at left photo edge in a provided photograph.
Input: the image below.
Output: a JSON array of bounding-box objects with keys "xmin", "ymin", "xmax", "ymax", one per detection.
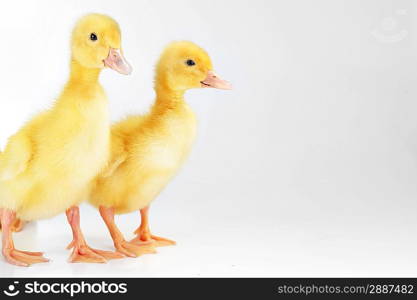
[{"xmin": 0, "ymin": 208, "xmax": 49, "ymax": 267}]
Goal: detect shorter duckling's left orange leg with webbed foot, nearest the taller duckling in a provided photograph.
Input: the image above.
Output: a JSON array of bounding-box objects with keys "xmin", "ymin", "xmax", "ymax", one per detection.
[{"xmin": 100, "ymin": 206, "xmax": 156, "ymax": 257}]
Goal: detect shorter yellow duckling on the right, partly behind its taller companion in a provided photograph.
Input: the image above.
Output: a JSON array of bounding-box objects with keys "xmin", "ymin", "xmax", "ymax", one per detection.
[{"xmin": 90, "ymin": 41, "xmax": 231, "ymax": 257}]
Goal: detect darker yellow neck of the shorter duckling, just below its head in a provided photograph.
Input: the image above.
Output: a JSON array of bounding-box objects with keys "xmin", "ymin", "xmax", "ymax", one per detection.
[{"xmin": 153, "ymin": 85, "xmax": 186, "ymax": 111}]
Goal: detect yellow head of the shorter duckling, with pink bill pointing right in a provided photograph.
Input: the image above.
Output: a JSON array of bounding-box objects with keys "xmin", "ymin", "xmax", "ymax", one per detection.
[{"xmin": 155, "ymin": 41, "xmax": 232, "ymax": 91}]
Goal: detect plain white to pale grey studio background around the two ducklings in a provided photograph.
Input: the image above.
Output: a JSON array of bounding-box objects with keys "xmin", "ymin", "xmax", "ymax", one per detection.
[{"xmin": 0, "ymin": 0, "xmax": 417, "ymax": 276}]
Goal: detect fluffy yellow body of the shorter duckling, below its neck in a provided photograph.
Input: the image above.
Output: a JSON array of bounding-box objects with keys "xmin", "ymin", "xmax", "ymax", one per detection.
[{"xmin": 91, "ymin": 95, "xmax": 196, "ymax": 214}]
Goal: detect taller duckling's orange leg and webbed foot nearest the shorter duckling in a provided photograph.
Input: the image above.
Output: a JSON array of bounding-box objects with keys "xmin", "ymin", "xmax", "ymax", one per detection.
[{"xmin": 66, "ymin": 206, "xmax": 123, "ymax": 263}]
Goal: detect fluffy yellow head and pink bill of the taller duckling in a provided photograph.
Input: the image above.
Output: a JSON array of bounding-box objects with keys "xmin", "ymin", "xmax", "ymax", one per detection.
[{"xmin": 71, "ymin": 14, "xmax": 132, "ymax": 75}]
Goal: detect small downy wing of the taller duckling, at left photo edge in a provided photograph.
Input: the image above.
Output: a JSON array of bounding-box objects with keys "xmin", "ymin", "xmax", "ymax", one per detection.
[{"xmin": 0, "ymin": 133, "xmax": 32, "ymax": 180}]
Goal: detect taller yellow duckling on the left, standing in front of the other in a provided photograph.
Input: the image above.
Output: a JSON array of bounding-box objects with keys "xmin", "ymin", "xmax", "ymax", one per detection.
[{"xmin": 0, "ymin": 14, "xmax": 131, "ymax": 266}]
